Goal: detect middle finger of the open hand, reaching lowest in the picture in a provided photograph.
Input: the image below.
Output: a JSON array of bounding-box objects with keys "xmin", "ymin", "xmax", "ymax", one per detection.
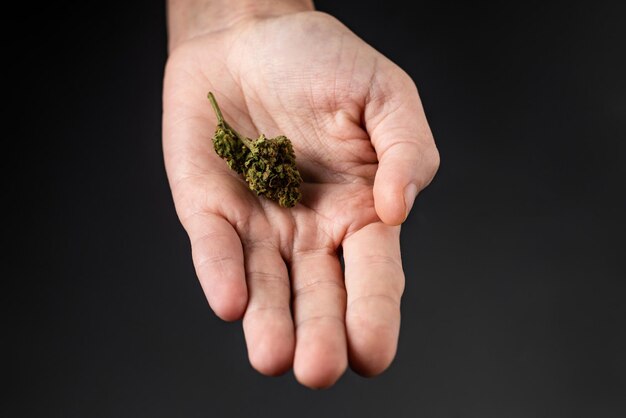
[{"xmin": 291, "ymin": 251, "xmax": 348, "ymax": 388}]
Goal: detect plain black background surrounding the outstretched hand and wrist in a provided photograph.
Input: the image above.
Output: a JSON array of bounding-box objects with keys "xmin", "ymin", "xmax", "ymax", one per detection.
[{"xmin": 6, "ymin": 0, "xmax": 626, "ymax": 417}]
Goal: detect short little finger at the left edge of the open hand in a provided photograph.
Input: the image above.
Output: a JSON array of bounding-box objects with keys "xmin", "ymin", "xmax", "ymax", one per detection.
[{"xmin": 182, "ymin": 213, "xmax": 248, "ymax": 321}]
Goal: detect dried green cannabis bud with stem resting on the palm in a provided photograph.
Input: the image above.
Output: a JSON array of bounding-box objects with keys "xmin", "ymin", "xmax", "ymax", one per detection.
[{"xmin": 209, "ymin": 92, "xmax": 302, "ymax": 208}]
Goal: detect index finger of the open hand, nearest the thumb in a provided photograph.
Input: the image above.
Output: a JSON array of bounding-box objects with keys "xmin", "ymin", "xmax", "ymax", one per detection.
[{"xmin": 343, "ymin": 223, "xmax": 404, "ymax": 376}]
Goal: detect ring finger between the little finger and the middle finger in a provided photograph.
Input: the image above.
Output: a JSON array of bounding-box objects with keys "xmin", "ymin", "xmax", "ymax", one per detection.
[{"xmin": 243, "ymin": 243, "xmax": 295, "ymax": 375}]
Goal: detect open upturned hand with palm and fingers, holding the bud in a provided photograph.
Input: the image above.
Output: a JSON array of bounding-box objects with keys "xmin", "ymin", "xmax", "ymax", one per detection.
[{"xmin": 163, "ymin": 11, "xmax": 439, "ymax": 387}]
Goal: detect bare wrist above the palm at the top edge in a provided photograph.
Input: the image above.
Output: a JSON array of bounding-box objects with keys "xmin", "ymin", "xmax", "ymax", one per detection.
[{"xmin": 167, "ymin": 0, "xmax": 314, "ymax": 51}]
